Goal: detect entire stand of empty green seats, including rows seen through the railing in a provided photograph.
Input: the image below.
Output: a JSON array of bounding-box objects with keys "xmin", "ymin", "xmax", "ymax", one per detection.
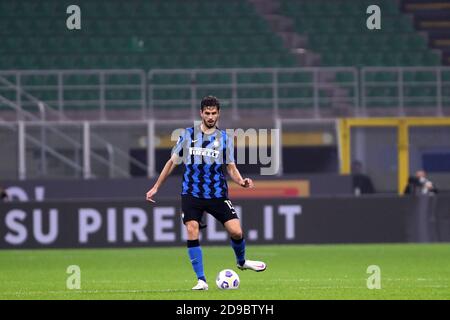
[{"xmin": 0, "ymin": 0, "xmax": 450, "ymax": 119}]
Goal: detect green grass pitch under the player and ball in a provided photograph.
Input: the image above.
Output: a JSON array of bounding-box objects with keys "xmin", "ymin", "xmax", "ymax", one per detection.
[{"xmin": 0, "ymin": 244, "xmax": 450, "ymax": 300}]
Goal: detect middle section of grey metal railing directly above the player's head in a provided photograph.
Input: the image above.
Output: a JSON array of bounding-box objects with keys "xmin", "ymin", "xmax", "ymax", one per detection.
[{"xmin": 148, "ymin": 67, "xmax": 359, "ymax": 120}]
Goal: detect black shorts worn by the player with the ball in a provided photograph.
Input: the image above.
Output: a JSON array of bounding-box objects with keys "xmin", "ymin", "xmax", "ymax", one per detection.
[{"xmin": 181, "ymin": 195, "xmax": 238, "ymax": 227}]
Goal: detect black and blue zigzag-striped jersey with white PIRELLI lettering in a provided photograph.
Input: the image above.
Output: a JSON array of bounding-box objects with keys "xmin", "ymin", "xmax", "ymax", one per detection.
[{"xmin": 172, "ymin": 125, "xmax": 234, "ymax": 199}]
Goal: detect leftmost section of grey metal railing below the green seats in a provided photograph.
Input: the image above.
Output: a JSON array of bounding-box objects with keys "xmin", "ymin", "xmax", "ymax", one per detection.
[{"xmin": 0, "ymin": 69, "xmax": 147, "ymax": 120}]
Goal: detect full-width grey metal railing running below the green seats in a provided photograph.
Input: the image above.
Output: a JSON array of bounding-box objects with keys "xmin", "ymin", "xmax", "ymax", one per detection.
[{"xmin": 0, "ymin": 67, "xmax": 450, "ymax": 120}]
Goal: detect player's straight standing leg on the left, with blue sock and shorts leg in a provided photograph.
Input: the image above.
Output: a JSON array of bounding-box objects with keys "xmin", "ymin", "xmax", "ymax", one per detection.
[{"xmin": 182, "ymin": 197, "xmax": 208, "ymax": 290}]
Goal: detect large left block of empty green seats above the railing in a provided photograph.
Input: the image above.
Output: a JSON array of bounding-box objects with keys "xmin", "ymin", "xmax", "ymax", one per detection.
[{"xmin": 0, "ymin": 0, "xmax": 295, "ymax": 70}]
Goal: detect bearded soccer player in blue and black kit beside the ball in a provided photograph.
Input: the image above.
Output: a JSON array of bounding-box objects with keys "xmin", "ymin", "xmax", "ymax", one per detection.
[{"xmin": 146, "ymin": 96, "xmax": 266, "ymax": 290}]
